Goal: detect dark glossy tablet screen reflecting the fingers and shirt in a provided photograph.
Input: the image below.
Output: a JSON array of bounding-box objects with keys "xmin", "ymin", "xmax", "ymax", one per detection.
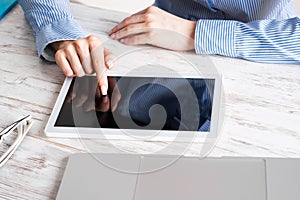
[{"xmin": 55, "ymin": 76, "xmax": 215, "ymax": 132}]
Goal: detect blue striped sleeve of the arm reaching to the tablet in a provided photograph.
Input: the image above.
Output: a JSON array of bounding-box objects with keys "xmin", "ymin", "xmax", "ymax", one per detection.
[{"xmin": 19, "ymin": 0, "xmax": 86, "ymax": 61}]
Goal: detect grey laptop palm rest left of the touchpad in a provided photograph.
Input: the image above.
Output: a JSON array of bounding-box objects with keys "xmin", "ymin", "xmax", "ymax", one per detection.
[{"xmin": 56, "ymin": 154, "xmax": 140, "ymax": 200}]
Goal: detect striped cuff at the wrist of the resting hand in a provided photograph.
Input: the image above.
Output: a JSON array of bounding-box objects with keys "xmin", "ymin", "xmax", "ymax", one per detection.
[{"xmin": 195, "ymin": 19, "xmax": 236, "ymax": 57}]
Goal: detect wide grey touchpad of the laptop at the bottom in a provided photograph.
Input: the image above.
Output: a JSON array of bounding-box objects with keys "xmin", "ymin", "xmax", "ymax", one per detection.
[{"xmin": 134, "ymin": 157, "xmax": 266, "ymax": 200}]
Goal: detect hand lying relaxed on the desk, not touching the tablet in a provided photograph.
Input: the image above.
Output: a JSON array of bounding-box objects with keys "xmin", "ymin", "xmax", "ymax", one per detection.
[{"xmin": 109, "ymin": 6, "xmax": 196, "ymax": 51}]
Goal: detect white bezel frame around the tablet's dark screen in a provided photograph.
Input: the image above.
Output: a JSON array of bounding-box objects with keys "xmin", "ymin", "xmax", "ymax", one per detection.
[{"xmin": 44, "ymin": 71, "xmax": 222, "ymax": 142}]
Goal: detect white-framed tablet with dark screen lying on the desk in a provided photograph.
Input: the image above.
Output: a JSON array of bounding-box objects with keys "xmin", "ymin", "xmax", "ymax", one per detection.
[{"xmin": 45, "ymin": 69, "xmax": 222, "ymax": 141}]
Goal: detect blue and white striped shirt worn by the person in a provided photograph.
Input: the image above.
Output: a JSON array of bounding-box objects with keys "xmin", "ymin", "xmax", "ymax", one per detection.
[{"xmin": 19, "ymin": 0, "xmax": 300, "ymax": 64}]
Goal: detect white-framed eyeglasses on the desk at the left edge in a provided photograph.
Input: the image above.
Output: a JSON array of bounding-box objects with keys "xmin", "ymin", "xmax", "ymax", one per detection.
[{"xmin": 0, "ymin": 115, "xmax": 33, "ymax": 167}]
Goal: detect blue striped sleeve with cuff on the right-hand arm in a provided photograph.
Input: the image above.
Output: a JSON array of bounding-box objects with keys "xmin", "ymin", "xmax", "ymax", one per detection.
[{"xmin": 195, "ymin": 17, "xmax": 300, "ymax": 64}]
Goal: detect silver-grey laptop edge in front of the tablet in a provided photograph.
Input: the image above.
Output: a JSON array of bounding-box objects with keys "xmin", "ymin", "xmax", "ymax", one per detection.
[{"xmin": 56, "ymin": 154, "xmax": 300, "ymax": 200}]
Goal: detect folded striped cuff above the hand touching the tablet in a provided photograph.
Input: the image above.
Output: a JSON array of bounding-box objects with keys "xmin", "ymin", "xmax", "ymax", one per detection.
[{"xmin": 36, "ymin": 18, "xmax": 87, "ymax": 61}]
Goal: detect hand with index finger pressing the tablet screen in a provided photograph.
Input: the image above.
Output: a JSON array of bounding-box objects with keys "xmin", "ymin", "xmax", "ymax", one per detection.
[{"xmin": 51, "ymin": 36, "xmax": 113, "ymax": 95}]
